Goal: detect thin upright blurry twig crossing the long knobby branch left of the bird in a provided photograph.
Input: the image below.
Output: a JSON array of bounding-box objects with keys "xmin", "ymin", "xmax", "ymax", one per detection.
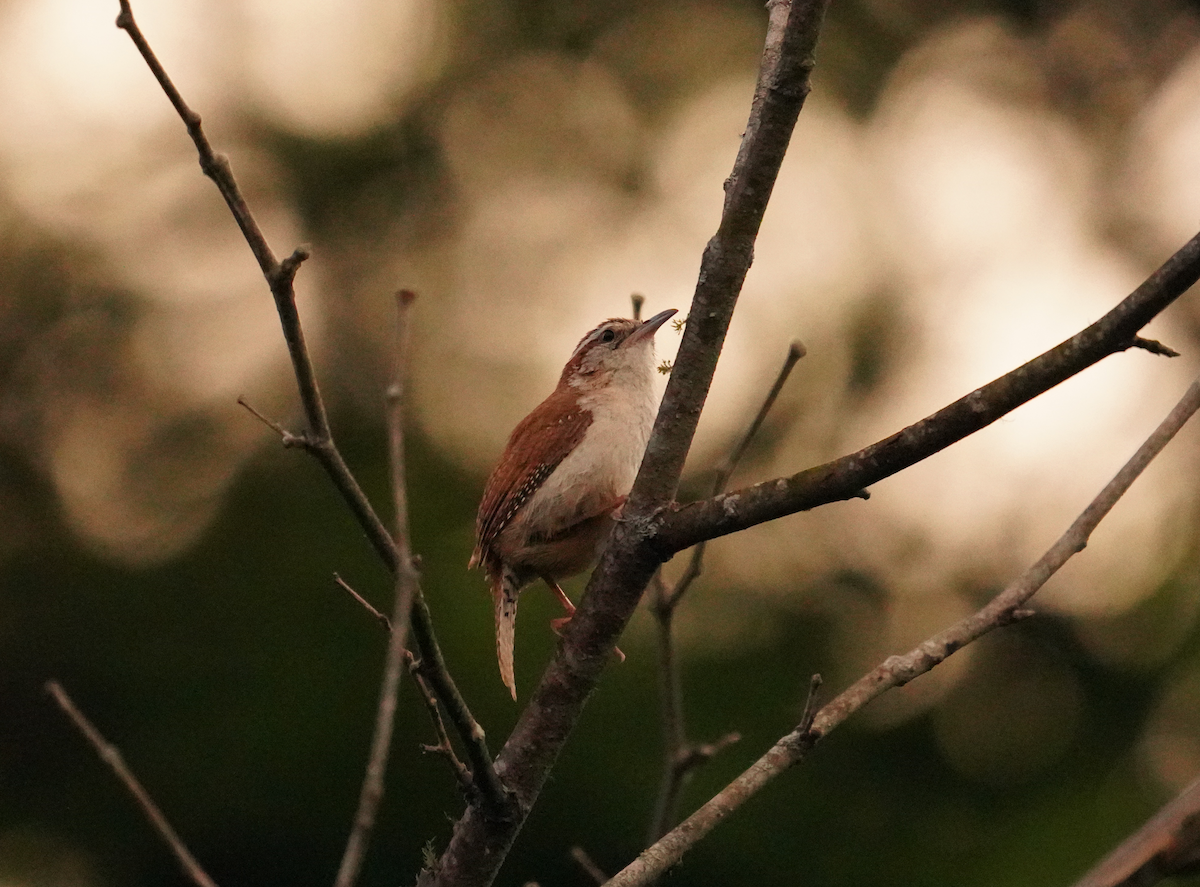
[{"xmin": 334, "ymin": 289, "xmax": 418, "ymax": 887}]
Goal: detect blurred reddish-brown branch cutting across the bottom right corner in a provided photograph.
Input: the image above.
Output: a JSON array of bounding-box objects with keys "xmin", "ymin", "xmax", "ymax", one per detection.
[{"xmin": 1074, "ymin": 779, "xmax": 1200, "ymax": 887}]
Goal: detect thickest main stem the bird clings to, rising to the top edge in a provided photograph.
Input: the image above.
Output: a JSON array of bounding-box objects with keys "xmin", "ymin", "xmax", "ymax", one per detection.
[{"xmin": 432, "ymin": 0, "xmax": 828, "ymax": 887}]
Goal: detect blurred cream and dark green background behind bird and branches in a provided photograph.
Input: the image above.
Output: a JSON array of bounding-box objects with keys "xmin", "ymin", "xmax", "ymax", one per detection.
[{"xmin": 0, "ymin": 0, "xmax": 1200, "ymax": 887}]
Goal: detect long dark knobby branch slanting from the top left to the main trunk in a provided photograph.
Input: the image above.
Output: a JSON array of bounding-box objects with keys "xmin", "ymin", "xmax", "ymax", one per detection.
[{"xmin": 116, "ymin": 0, "xmax": 508, "ymax": 815}]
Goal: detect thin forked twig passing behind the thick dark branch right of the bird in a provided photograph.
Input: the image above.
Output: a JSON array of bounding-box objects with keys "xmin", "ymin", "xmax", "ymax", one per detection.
[{"xmin": 647, "ymin": 341, "xmax": 805, "ymax": 845}]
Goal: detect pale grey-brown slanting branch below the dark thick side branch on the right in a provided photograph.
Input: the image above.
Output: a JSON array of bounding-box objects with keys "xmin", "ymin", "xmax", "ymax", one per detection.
[{"xmin": 610, "ymin": 369, "xmax": 1200, "ymax": 887}]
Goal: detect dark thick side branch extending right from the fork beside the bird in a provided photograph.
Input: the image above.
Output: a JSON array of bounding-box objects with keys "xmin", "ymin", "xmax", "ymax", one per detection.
[{"xmin": 655, "ymin": 223, "xmax": 1200, "ymax": 558}]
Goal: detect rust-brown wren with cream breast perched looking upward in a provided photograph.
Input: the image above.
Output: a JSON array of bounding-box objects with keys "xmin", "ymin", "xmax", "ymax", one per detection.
[{"xmin": 469, "ymin": 308, "xmax": 676, "ymax": 699}]
